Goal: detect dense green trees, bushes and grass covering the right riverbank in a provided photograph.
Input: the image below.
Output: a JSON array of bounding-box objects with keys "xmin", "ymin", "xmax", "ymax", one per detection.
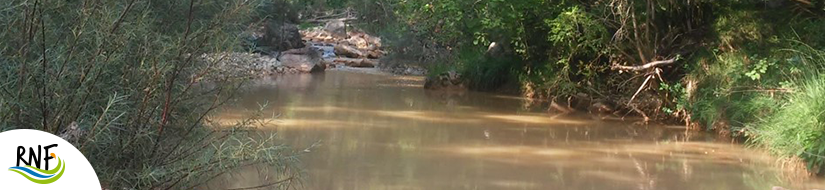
[{"xmin": 302, "ymin": 0, "xmax": 825, "ymax": 173}]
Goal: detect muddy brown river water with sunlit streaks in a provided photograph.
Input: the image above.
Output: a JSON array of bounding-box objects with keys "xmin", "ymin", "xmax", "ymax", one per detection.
[{"xmin": 208, "ymin": 71, "xmax": 822, "ymax": 190}]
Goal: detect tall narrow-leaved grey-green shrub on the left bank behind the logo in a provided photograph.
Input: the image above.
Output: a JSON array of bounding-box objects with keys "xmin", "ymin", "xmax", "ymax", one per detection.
[{"xmin": 0, "ymin": 0, "xmax": 296, "ymax": 189}]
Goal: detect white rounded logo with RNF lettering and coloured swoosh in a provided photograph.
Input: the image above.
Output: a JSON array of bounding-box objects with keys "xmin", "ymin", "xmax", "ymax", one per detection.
[{"xmin": 0, "ymin": 129, "xmax": 100, "ymax": 190}]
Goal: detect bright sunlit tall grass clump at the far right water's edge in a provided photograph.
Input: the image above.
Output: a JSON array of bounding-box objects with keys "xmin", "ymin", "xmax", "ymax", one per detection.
[{"xmin": 751, "ymin": 47, "xmax": 825, "ymax": 174}]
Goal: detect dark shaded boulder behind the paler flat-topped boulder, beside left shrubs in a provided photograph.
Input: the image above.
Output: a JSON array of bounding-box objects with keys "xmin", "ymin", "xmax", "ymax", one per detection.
[{"xmin": 259, "ymin": 21, "xmax": 305, "ymax": 51}]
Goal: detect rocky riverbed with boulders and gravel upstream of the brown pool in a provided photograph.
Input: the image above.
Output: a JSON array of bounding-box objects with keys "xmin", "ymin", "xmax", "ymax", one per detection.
[{"xmin": 201, "ymin": 20, "xmax": 427, "ymax": 77}]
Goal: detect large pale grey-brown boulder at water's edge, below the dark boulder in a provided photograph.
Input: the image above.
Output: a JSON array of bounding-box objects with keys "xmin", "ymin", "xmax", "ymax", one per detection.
[{"xmin": 278, "ymin": 47, "xmax": 326, "ymax": 73}]
